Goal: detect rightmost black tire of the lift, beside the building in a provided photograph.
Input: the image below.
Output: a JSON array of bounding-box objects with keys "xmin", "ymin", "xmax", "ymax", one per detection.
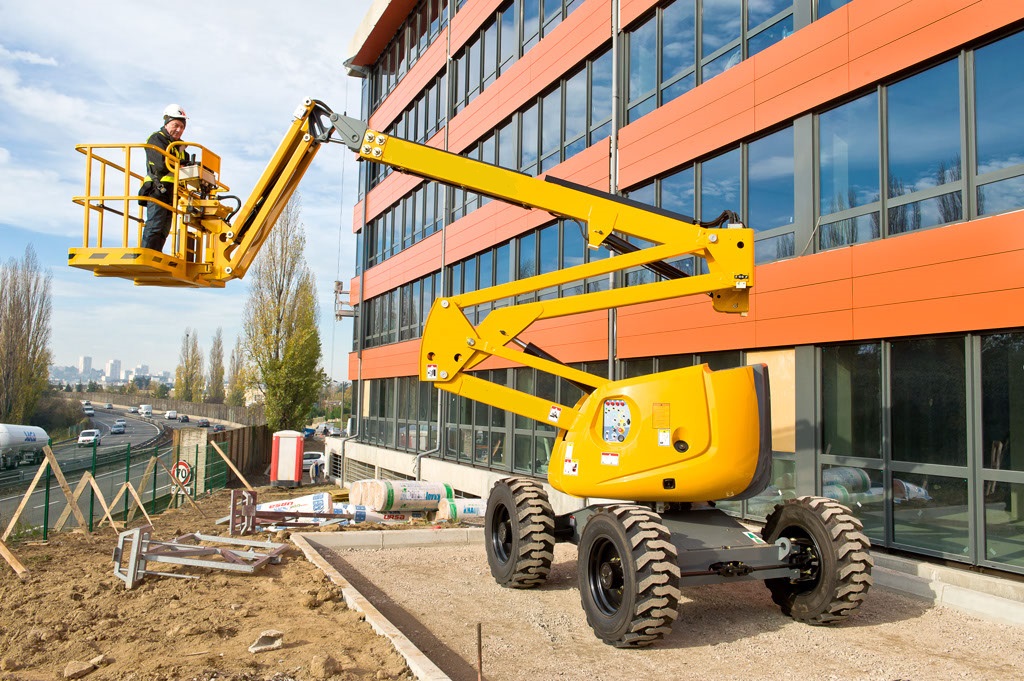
[{"xmin": 761, "ymin": 497, "xmax": 874, "ymax": 625}]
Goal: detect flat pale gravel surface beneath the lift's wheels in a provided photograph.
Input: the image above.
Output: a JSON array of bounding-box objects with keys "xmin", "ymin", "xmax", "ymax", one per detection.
[{"xmin": 323, "ymin": 544, "xmax": 1024, "ymax": 681}]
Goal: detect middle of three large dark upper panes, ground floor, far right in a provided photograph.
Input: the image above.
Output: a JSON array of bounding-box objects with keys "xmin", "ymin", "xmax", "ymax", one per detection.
[{"xmin": 891, "ymin": 337, "xmax": 967, "ymax": 466}]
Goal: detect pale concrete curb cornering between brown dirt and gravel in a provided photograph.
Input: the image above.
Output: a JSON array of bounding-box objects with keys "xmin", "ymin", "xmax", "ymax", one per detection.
[{"xmin": 292, "ymin": 530, "xmax": 452, "ymax": 681}]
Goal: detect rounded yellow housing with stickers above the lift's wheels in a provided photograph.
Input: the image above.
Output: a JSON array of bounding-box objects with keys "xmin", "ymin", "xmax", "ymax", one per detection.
[{"xmin": 548, "ymin": 365, "xmax": 771, "ymax": 502}]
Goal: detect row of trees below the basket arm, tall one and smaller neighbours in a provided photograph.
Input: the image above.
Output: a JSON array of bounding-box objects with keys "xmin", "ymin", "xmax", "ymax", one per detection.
[{"xmin": 174, "ymin": 199, "xmax": 327, "ymax": 430}]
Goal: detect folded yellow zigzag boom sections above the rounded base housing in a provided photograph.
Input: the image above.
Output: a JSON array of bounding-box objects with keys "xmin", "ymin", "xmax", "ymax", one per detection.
[{"xmin": 331, "ymin": 114, "xmax": 754, "ymax": 429}]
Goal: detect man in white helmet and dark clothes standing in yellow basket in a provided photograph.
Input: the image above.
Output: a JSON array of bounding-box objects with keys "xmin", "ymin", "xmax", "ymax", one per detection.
[{"xmin": 139, "ymin": 104, "xmax": 188, "ymax": 251}]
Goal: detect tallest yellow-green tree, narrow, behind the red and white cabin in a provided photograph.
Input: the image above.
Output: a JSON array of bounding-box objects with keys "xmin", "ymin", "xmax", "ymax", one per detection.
[{"xmin": 244, "ymin": 198, "xmax": 326, "ymax": 430}]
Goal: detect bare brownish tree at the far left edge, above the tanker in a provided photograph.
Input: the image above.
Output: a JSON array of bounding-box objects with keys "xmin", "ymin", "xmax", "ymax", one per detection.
[{"xmin": 0, "ymin": 246, "xmax": 52, "ymax": 423}]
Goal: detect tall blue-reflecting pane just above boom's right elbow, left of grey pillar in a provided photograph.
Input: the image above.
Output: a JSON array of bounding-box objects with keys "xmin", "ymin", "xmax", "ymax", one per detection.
[{"xmin": 746, "ymin": 127, "xmax": 796, "ymax": 231}]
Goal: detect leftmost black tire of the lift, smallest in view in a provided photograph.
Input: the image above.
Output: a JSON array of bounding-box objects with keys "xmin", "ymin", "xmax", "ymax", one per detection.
[{"xmin": 484, "ymin": 477, "xmax": 555, "ymax": 589}]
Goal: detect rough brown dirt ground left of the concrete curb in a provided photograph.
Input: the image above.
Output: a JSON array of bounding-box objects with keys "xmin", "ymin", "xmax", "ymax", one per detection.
[{"xmin": 0, "ymin": 485, "xmax": 413, "ymax": 681}]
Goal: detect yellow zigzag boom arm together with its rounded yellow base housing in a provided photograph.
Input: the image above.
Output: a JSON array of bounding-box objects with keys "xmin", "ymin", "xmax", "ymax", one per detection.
[{"xmin": 331, "ymin": 115, "xmax": 771, "ymax": 502}]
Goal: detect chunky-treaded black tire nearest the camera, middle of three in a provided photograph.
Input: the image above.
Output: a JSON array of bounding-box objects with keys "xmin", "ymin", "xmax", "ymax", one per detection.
[{"xmin": 578, "ymin": 504, "xmax": 679, "ymax": 648}]
